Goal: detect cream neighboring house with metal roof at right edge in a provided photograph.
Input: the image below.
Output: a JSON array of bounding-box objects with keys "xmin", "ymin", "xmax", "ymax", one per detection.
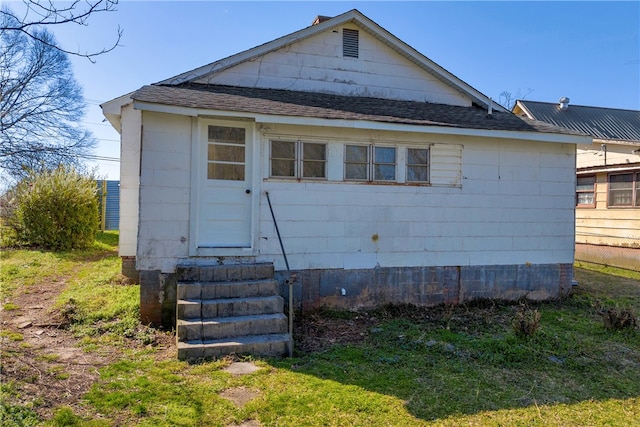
[{"xmin": 513, "ymin": 97, "xmax": 640, "ymax": 271}]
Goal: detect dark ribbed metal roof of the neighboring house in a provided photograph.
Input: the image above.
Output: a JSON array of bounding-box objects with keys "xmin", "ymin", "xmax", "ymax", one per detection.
[{"xmin": 514, "ymin": 100, "xmax": 640, "ymax": 143}]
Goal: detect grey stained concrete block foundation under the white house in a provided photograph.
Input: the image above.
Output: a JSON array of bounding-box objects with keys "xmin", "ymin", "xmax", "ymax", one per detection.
[{"xmin": 140, "ymin": 264, "xmax": 573, "ymax": 328}]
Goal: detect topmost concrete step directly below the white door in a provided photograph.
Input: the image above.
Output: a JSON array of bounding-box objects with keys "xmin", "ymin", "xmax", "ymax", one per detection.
[{"xmin": 176, "ymin": 263, "xmax": 274, "ymax": 282}]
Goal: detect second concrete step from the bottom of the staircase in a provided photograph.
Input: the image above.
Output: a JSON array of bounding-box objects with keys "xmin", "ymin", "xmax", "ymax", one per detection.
[{"xmin": 177, "ymin": 313, "xmax": 288, "ymax": 342}]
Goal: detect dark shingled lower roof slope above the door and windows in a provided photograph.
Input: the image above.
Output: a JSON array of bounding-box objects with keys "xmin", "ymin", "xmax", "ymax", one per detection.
[{"xmin": 132, "ymin": 83, "xmax": 582, "ymax": 135}]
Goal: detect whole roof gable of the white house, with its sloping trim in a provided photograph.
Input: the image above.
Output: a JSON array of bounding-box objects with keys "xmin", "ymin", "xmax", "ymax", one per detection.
[{"xmin": 159, "ymin": 9, "xmax": 505, "ymax": 111}]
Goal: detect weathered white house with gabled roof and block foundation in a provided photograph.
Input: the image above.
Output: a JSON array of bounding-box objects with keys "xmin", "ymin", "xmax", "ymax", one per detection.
[{"xmin": 102, "ymin": 10, "xmax": 590, "ymax": 354}]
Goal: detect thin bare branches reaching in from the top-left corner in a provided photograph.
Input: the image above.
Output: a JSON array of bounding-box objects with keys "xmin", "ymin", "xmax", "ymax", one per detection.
[{"xmin": 0, "ymin": 0, "xmax": 122, "ymax": 62}]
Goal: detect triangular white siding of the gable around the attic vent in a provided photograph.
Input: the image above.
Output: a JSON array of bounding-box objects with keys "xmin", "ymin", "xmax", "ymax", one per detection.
[{"xmin": 192, "ymin": 26, "xmax": 471, "ymax": 106}]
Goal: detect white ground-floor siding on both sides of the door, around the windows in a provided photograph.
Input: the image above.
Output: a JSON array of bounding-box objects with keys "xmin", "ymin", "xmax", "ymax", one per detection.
[{"xmin": 138, "ymin": 117, "xmax": 574, "ymax": 278}]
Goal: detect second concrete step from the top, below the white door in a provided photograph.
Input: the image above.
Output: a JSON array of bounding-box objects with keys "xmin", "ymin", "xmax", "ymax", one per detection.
[{"xmin": 178, "ymin": 279, "xmax": 278, "ymax": 299}]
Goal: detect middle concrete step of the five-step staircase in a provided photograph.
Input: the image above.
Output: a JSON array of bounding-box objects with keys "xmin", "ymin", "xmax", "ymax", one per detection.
[{"xmin": 178, "ymin": 295, "xmax": 284, "ymax": 320}]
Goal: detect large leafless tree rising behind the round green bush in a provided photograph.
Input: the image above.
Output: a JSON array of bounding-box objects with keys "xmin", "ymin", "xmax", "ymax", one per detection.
[{"xmin": 0, "ymin": 14, "xmax": 95, "ymax": 178}]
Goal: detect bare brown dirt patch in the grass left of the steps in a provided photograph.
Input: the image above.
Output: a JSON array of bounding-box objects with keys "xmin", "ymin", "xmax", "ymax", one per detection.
[{"xmin": 0, "ymin": 264, "xmax": 175, "ymax": 419}]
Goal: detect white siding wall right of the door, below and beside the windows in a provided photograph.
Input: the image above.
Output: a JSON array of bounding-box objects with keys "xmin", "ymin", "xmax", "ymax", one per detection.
[{"xmin": 251, "ymin": 129, "xmax": 574, "ymax": 269}]
